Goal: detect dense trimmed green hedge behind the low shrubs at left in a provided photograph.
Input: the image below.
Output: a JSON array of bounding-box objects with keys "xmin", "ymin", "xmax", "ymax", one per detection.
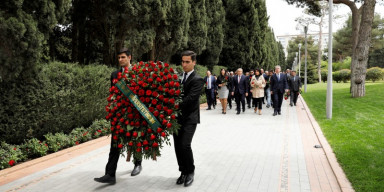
[{"xmin": 0, "ymin": 62, "xmax": 115, "ymax": 144}]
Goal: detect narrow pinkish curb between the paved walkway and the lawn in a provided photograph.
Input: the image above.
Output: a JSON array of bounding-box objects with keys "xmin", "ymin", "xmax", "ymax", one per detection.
[{"xmin": 300, "ymin": 97, "xmax": 355, "ymax": 192}]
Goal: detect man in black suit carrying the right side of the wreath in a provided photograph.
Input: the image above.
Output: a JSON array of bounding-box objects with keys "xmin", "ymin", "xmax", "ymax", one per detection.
[{"xmin": 173, "ymin": 51, "xmax": 205, "ymax": 187}]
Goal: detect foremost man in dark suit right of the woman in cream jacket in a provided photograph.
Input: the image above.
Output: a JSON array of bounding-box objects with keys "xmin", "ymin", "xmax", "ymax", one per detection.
[{"xmin": 270, "ymin": 65, "xmax": 288, "ymax": 116}]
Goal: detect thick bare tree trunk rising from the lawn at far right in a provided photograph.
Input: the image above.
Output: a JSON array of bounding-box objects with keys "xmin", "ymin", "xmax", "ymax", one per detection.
[{"xmin": 351, "ymin": 0, "xmax": 376, "ymax": 98}]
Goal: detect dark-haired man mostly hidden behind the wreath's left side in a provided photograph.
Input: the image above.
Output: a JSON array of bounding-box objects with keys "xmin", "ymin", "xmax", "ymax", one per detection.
[{"xmin": 94, "ymin": 48, "xmax": 142, "ymax": 184}]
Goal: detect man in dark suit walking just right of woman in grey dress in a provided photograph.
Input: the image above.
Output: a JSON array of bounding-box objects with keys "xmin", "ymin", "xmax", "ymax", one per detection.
[{"xmin": 232, "ymin": 68, "xmax": 249, "ymax": 115}]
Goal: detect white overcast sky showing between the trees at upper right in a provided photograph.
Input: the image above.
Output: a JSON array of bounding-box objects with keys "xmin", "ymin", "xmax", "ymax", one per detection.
[{"xmin": 266, "ymin": 0, "xmax": 384, "ymax": 36}]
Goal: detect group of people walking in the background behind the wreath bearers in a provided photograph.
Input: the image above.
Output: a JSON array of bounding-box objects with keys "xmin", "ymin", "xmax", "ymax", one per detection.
[{"xmin": 204, "ymin": 65, "xmax": 301, "ymax": 116}]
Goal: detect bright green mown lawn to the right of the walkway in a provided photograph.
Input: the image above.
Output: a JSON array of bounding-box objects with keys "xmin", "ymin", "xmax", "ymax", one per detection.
[{"xmin": 303, "ymin": 82, "xmax": 384, "ymax": 192}]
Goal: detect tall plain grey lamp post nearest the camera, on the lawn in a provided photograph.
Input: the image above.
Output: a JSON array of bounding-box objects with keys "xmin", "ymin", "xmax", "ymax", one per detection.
[{"xmin": 326, "ymin": 1, "xmax": 333, "ymax": 119}]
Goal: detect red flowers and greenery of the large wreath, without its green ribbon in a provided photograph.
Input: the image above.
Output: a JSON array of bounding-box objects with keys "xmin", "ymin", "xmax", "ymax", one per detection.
[{"xmin": 106, "ymin": 61, "xmax": 181, "ymax": 159}]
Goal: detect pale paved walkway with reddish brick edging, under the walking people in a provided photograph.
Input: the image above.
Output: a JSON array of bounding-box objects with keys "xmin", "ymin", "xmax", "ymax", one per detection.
[{"xmin": 0, "ymin": 99, "xmax": 353, "ymax": 192}]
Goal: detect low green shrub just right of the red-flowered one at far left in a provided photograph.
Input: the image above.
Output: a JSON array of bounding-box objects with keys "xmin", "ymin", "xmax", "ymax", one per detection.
[{"xmin": 20, "ymin": 138, "xmax": 48, "ymax": 158}]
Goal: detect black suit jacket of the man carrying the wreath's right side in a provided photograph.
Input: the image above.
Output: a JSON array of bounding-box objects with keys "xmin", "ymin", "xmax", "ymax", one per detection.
[{"xmin": 178, "ymin": 71, "xmax": 205, "ymax": 125}]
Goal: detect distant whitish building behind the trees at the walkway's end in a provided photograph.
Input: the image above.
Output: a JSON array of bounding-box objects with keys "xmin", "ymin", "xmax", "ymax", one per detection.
[{"xmin": 277, "ymin": 33, "xmax": 328, "ymax": 57}]
